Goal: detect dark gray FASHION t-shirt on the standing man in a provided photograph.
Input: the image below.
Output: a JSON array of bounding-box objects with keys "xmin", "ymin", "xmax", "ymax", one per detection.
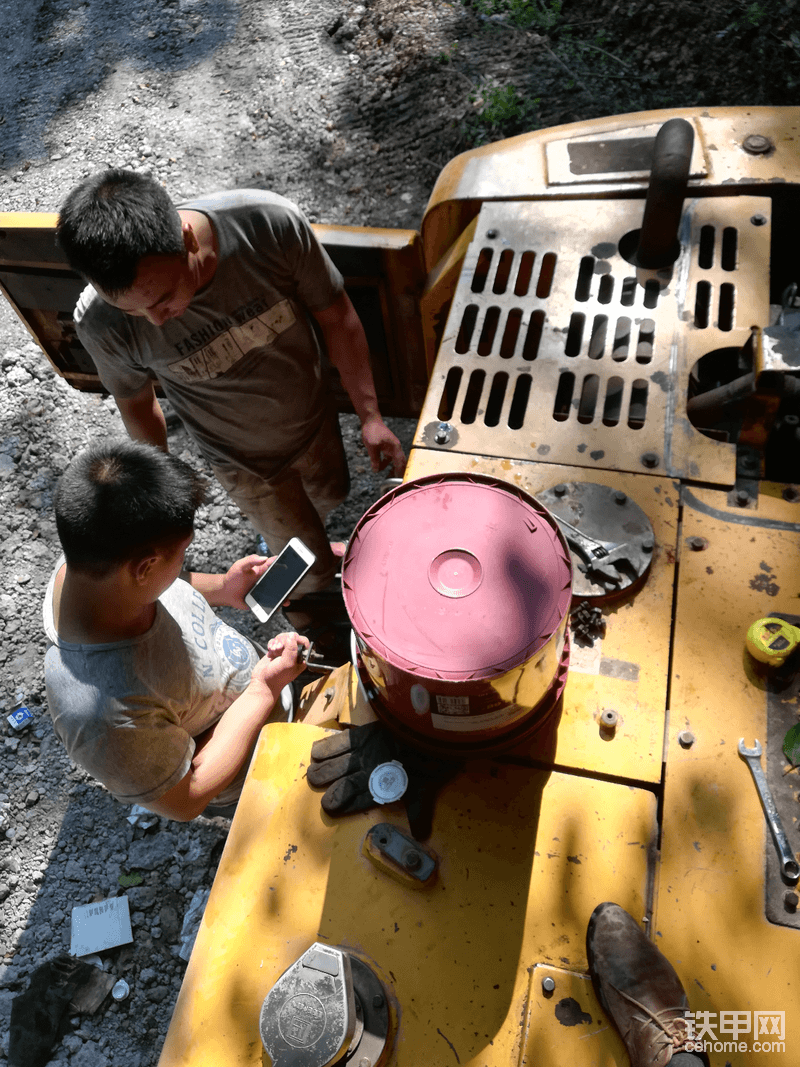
[{"xmin": 75, "ymin": 189, "xmax": 343, "ymax": 478}]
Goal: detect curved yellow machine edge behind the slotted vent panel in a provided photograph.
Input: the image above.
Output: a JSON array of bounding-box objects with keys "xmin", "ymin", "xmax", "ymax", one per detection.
[{"xmin": 422, "ymin": 108, "xmax": 800, "ymax": 270}]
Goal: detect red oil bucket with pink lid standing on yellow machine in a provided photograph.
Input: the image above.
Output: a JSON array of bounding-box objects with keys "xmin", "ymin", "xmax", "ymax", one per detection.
[{"xmin": 342, "ymin": 473, "xmax": 572, "ymax": 753}]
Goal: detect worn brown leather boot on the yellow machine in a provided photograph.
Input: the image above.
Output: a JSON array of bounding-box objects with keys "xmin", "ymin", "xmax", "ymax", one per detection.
[{"xmin": 586, "ymin": 902, "xmax": 704, "ymax": 1067}]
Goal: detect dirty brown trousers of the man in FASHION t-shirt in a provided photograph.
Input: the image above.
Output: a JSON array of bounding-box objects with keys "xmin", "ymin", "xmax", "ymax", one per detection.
[{"xmin": 213, "ymin": 411, "xmax": 350, "ymax": 593}]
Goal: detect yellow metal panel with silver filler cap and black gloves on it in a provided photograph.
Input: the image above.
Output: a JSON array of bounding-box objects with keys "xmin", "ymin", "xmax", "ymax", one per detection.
[{"xmin": 160, "ymin": 723, "xmax": 656, "ymax": 1067}]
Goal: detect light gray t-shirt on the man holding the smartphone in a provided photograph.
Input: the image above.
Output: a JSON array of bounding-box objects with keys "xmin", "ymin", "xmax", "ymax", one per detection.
[{"xmin": 44, "ymin": 559, "xmax": 258, "ymax": 803}]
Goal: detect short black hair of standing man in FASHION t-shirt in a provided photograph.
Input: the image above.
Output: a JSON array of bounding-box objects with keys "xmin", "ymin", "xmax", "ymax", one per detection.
[{"xmin": 55, "ymin": 170, "xmax": 186, "ymax": 297}]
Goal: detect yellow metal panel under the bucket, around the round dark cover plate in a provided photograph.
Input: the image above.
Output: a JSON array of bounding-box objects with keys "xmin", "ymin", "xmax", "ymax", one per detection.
[{"xmin": 405, "ymin": 448, "xmax": 678, "ymax": 783}]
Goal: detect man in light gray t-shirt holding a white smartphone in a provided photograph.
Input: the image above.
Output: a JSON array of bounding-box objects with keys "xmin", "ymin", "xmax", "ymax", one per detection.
[{"xmin": 44, "ymin": 441, "xmax": 308, "ymax": 821}]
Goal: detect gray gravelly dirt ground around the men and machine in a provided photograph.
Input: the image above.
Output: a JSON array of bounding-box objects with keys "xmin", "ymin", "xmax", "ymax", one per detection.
[{"xmin": 0, "ymin": 0, "xmax": 800, "ymax": 1067}]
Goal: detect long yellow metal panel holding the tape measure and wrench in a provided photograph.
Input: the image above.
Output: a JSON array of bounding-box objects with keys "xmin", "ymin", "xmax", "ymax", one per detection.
[{"xmin": 654, "ymin": 483, "xmax": 800, "ymax": 1067}]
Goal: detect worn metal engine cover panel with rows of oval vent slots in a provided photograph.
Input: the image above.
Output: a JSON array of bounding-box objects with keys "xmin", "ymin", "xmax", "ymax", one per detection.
[{"xmin": 415, "ymin": 196, "xmax": 770, "ymax": 485}]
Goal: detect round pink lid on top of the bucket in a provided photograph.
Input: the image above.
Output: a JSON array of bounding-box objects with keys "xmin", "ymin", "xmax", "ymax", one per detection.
[{"xmin": 342, "ymin": 474, "xmax": 572, "ymax": 681}]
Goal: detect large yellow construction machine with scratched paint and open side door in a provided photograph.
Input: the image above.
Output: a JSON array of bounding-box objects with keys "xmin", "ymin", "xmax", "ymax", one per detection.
[{"xmin": 0, "ymin": 108, "xmax": 800, "ymax": 1067}]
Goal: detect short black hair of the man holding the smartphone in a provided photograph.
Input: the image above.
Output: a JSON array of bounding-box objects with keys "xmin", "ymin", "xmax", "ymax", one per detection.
[{"xmin": 53, "ymin": 440, "xmax": 205, "ymax": 577}]
